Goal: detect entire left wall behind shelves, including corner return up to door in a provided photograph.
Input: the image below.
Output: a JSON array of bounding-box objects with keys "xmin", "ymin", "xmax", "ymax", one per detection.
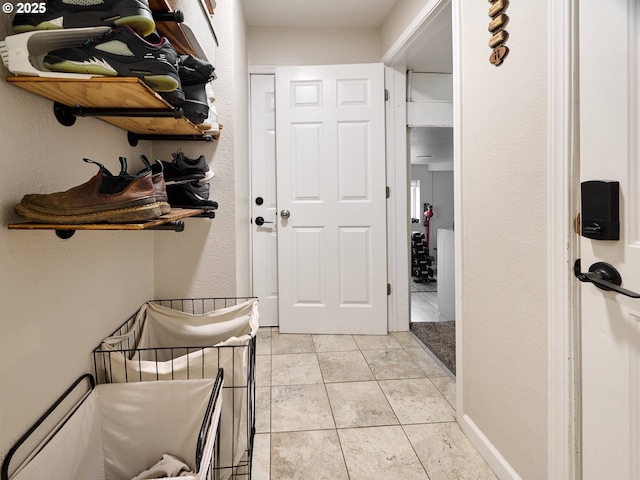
[{"xmin": 0, "ymin": 2, "xmax": 249, "ymax": 461}]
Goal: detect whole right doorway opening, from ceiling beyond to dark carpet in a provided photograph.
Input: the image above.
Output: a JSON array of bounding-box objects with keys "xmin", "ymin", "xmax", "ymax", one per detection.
[{"xmin": 389, "ymin": 1, "xmax": 456, "ymax": 375}]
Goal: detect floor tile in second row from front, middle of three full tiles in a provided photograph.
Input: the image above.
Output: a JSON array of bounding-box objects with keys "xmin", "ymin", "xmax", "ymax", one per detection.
[{"xmin": 326, "ymin": 382, "xmax": 398, "ymax": 428}]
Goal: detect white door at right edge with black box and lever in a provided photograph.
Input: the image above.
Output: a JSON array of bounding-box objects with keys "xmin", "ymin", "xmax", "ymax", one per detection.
[{"xmin": 579, "ymin": 0, "xmax": 640, "ymax": 480}]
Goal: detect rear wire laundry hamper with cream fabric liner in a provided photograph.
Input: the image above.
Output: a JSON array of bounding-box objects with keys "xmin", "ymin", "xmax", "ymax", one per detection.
[{"xmin": 93, "ymin": 297, "xmax": 258, "ymax": 480}]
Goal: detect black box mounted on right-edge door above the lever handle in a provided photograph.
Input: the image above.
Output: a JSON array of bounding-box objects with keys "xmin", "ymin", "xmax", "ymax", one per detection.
[{"xmin": 580, "ymin": 180, "xmax": 620, "ymax": 240}]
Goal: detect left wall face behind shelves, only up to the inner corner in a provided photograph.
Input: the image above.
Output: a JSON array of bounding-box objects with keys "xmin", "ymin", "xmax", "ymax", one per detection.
[{"xmin": 0, "ymin": 15, "xmax": 154, "ymax": 459}]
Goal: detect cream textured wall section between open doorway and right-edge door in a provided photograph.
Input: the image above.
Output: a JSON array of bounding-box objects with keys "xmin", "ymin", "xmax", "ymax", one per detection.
[{"xmin": 456, "ymin": 1, "xmax": 549, "ymax": 479}]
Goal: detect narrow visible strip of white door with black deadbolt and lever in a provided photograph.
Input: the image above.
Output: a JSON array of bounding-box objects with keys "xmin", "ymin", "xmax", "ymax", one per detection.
[{"xmin": 250, "ymin": 75, "xmax": 278, "ymax": 326}]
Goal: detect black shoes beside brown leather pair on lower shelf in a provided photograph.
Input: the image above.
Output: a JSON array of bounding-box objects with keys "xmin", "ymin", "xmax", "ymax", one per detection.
[{"xmin": 159, "ymin": 150, "xmax": 218, "ymax": 210}]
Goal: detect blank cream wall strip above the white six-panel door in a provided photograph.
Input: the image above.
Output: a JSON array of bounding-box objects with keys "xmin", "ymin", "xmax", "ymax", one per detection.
[{"xmin": 247, "ymin": 27, "xmax": 381, "ymax": 66}]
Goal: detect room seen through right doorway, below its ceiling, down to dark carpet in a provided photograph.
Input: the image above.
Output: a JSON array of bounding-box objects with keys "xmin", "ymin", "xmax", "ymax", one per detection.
[{"xmin": 407, "ymin": 70, "xmax": 456, "ymax": 375}]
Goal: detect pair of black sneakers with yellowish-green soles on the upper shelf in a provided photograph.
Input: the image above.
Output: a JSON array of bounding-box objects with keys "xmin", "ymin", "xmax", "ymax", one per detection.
[{"xmin": 13, "ymin": 0, "xmax": 190, "ymax": 105}]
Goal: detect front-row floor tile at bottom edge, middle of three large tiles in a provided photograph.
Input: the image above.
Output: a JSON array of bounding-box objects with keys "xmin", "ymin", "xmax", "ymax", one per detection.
[{"xmin": 338, "ymin": 426, "xmax": 429, "ymax": 480}]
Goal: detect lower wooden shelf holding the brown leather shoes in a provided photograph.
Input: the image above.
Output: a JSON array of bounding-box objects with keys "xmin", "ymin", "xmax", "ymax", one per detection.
[{"xmin": 8, "ymin": 208, "xmax": 215, "ymax": 238}]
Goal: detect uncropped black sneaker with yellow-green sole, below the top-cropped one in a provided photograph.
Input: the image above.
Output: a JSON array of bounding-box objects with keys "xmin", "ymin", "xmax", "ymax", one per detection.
[{"xmin": 43, "ymin": 25, "xmax": 180, "ymax": 92}]
